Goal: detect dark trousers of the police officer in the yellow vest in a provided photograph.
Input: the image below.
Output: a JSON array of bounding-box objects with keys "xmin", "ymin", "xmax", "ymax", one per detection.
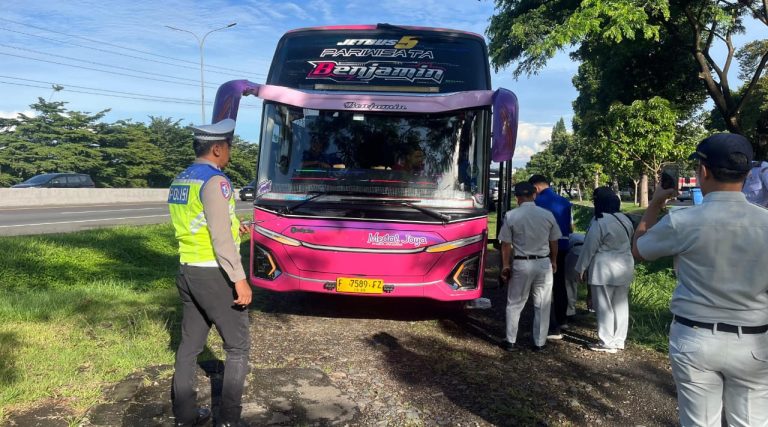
[{"xmin": 172, "ymin": 265, "xmax": 250, "ymax": 425}]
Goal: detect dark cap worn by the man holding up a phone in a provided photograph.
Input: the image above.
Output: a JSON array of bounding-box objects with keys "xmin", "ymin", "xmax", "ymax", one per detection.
[{"xmin": 688, "ymin": 133, "xmax": 752, "ymax": 172}]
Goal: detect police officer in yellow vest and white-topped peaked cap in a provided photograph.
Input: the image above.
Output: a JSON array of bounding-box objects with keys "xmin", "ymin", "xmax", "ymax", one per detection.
[{"xmin": 168, "ymin": 119, "xmax": 251, "ymax": 426}]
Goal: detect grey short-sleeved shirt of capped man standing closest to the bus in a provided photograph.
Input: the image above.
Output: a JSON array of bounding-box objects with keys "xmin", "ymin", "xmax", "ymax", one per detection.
[{"xmin": 499, "ymin": 202, "xmax": 562, "ymax": 256}]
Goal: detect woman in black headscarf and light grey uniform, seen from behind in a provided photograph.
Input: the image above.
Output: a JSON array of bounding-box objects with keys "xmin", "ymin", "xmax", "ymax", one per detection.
[{"xmin": 575, "ymin": 187, "xmax": 635, "ymax": 353}]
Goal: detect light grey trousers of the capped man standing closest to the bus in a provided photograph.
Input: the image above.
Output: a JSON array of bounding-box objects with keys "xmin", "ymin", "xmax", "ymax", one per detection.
[{"xmin": 507, "ymin": 258, "xmax": 552, "ymax": 346}]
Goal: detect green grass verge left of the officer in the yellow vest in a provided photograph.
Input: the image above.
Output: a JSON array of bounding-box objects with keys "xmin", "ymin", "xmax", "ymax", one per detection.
[{"xmin": 0, "ymin": 224, "xmax": 243, "ymax": 418}]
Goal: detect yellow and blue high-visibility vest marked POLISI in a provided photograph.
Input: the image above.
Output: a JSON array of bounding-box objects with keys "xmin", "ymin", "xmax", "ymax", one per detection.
[{"xmin": 168, "ymin": 163, "xmax": 240, "ymax": 263}]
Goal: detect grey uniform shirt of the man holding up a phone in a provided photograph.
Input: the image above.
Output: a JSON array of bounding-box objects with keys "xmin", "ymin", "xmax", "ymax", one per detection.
[{"xmin": 637, "ymin": 191, "xmax": 768, "ymax": 326}]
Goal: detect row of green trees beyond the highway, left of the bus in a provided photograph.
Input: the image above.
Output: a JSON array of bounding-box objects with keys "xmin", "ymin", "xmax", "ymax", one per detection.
[{"xmin": 0, "ymin": 98, "xmax": 258, "ymax": 188}]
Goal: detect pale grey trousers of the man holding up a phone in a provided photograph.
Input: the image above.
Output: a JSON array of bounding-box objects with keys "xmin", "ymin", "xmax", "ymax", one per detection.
[{"xmin": 669, "ymin": 321, "xmax": 768, "ymax": 427}]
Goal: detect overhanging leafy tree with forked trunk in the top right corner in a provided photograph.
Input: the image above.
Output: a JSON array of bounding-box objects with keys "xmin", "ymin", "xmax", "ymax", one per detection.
[{"xmin": 487, "ymin": 0, "xmax": 768, "ymax": 144}]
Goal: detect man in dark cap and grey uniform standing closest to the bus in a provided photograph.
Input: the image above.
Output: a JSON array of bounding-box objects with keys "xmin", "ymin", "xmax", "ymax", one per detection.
[{"xmin": 499, "ymin": 182, "xmax": 561, "ymax": 351}]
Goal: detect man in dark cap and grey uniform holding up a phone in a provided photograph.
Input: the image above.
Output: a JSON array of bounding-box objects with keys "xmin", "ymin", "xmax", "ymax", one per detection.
[{"xmin": 632, "ymin": 133, "xmax": 768, "ymax": 426}]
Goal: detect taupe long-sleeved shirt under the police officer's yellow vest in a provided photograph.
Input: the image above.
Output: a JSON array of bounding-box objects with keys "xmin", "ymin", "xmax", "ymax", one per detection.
[{"xmin": 195, "ymin": 160, "xmax": 245, "ymax": 282}]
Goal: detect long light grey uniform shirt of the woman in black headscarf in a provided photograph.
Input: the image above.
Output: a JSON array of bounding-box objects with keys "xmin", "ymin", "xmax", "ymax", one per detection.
[{"xmin": 575, "ymin": 213, "xmax": 635, "ymax": 286}]
